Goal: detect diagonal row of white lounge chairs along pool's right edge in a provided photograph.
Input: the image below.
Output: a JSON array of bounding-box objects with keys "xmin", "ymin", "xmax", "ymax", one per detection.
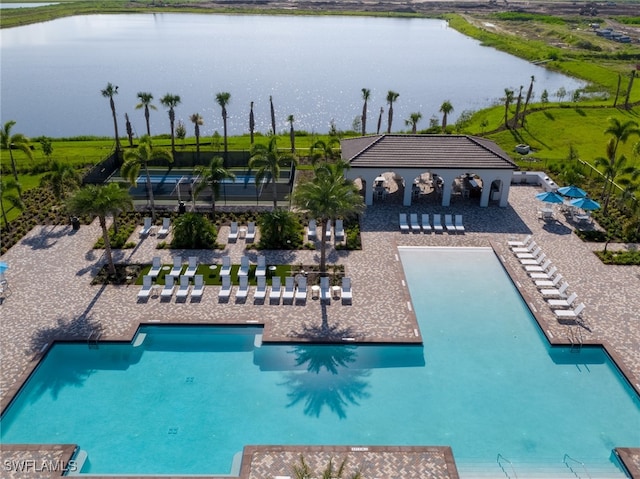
[{"xmin": 508, "ymin": 235, "xmax": 585, "ymax": 320}]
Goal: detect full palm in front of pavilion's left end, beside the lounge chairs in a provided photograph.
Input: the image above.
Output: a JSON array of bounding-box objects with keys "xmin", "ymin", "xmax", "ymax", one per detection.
[{"xmin": 292, "ymin": 160, "xmax": 364, "ymax": 274}]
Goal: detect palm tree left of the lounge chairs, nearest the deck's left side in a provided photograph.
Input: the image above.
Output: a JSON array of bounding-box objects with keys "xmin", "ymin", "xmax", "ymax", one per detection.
[{"xmin": 67, "ymin": 183, "xmax": 133, "ymax": 275}]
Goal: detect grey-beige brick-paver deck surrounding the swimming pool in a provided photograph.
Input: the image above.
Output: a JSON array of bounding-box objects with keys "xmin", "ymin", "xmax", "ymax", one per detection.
[{"xmin": 0, "ymin": 186, "xmax": 640, "ymax": 478}]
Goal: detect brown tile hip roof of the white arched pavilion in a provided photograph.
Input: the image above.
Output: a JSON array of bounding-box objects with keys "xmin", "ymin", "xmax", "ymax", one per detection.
[{"xmin": 340, "ymin": 135, "xmax": 517, "ymax": 170}]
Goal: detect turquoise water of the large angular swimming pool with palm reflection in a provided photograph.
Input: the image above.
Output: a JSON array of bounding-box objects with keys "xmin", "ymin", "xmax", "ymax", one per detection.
[{"xmin": 1, "ymin": 248, "xmax": 640, "ymax": 474}]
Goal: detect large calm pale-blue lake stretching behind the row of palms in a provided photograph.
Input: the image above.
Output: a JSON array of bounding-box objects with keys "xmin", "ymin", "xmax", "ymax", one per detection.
[{"xmin": 0, "ymin": 14, "xmax": 583, "ymax": 137}]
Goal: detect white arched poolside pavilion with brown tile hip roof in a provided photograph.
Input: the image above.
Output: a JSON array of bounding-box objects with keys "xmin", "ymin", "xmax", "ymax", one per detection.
[{"xmin": 340, "ymin": 135, "xmax": 518, "ymax": 207}]
